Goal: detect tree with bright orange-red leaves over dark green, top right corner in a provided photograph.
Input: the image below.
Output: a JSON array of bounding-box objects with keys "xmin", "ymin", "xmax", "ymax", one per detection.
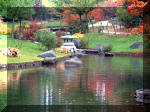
[{"xmin": 116, "ymin": 0, "xmax": 147, "ymax": 28}]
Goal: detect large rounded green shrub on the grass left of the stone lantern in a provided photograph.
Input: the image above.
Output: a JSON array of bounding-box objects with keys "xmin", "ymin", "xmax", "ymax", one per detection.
[{"xmin": 34, "ymin": 29, "xmax": 57, "ymax": 50}]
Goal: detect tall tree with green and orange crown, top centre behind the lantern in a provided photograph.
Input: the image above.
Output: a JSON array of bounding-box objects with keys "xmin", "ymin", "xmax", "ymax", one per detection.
[{"xmin": 56, "ymin": 0, "xmax": 103, "ymax": 33}]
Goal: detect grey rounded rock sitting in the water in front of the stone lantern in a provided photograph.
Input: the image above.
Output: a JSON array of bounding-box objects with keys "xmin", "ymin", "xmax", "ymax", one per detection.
[{"xmin": 65, "ymin": 57, "xmax": 82, "ymax": 66}]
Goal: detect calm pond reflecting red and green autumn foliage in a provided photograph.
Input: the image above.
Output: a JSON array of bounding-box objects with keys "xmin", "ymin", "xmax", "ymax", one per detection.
[{"xmin": 0, "ymin": 55, "xmax": 143, "ymax": 110}]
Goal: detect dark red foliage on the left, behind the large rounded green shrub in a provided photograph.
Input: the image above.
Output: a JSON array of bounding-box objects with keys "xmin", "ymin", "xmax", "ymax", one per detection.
[{"xmin": 21, "ymin": 18, "xmax": 43, "ymax": 40}]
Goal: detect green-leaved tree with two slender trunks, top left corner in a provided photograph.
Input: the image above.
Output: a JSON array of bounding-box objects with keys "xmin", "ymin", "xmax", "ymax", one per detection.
[{"xmin": 0, "ymin": 0, "xmax": 34, "ymax": 38}]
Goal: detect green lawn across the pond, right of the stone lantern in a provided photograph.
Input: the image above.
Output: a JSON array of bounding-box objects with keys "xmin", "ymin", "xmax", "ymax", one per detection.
[{"xmin": 85, "ymin": 32, "xmax": 143, "ymax": 52}]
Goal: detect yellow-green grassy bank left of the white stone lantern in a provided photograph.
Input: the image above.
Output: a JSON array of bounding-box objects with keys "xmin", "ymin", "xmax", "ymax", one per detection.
[{"xmin": 0, "ymin": 35, "xmax": 67, "ymax": 64}]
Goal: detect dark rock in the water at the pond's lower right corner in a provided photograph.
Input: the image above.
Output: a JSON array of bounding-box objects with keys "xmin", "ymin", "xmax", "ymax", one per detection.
[{"xmin": 135, "ymin": 89, "xmax": 150, "ymax": 103}]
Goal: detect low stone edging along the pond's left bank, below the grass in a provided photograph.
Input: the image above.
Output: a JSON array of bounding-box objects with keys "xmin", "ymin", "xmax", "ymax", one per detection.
[{"xmin": 0, "ymin": 56, "xmax": 69, "ymax": 70}]
